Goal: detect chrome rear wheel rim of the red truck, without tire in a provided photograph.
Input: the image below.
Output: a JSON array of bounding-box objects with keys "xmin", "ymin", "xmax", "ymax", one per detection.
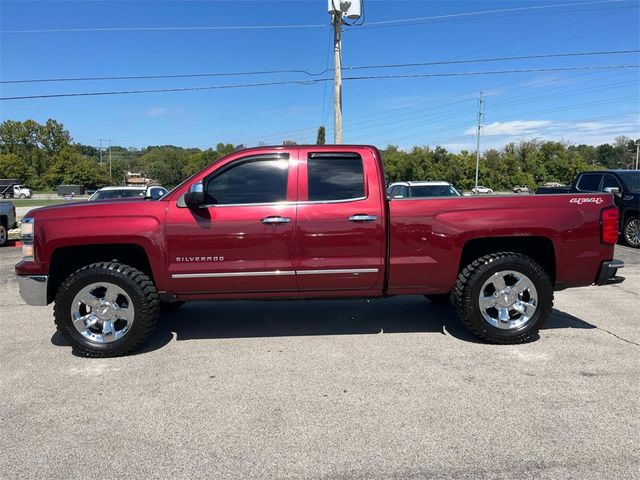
[{"xmin": 478, "ymin": 270, "xmax": 538, "ymax": 330}]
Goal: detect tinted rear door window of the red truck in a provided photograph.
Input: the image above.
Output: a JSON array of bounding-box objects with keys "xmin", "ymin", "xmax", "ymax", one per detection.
[{"xmin": 307, "ymin": 156, "xmax": 365, "ymax": 201}]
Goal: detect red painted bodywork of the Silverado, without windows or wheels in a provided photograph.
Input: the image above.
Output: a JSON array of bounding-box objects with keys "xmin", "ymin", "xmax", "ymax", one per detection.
[{"xmin": 16, "ymin": 145, "xmax": 613, "ymax": 299}]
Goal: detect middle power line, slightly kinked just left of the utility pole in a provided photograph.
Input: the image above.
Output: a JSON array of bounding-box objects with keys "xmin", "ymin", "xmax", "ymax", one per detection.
[{"xmin": 0, "ymin": 49, "xmax": 640, "ymax": 84}]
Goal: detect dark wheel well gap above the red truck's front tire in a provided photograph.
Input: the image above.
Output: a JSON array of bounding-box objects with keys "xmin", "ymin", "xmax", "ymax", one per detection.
[{"xmin": 47, "ymin": 244, "xmax": 153, "ymax": 302}]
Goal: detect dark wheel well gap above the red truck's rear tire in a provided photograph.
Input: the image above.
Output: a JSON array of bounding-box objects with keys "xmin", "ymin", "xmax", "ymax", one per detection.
[{"xmin": 458, "ymin": 237, "xmax": 556, "ymax": 284}]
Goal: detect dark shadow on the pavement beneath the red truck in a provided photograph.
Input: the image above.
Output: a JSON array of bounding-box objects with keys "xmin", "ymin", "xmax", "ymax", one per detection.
[{"xmin": 51, "ymin": 296, "xmax": 596, "ymax": 355}]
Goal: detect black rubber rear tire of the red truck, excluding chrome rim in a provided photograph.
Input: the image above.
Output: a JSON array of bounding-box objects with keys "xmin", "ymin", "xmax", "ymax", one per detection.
[{"xmin": 453, "ymin": 252, "xmax": 553, "ymax": 344}]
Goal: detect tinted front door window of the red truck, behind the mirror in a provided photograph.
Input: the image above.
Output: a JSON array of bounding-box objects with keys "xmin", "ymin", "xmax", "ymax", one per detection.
[{"xmin": 206, "ymin": 159, "xmax": 289, "ymax": 205}]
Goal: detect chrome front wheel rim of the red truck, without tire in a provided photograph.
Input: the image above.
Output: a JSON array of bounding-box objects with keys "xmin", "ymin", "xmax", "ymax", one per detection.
[{"xmin": 71, "ymin": 282, "xmax": 135, "ymax": 343}]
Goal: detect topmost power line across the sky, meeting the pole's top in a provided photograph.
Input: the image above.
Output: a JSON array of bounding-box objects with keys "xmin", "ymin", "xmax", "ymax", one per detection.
[{"xmin": 0, "ymin": 0, "xmax": 622, "ymax": 34}]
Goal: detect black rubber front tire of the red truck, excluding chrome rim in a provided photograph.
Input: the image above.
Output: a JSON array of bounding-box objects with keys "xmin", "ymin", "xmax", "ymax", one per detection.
[{"xmin": 53, "ymin": 262, "xmax": 160, "ymax": 357}]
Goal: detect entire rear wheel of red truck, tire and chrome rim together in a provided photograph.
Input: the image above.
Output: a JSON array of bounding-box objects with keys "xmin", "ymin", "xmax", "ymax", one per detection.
[{"xmin": 454, "ymin": 252, "xmax": 553, "ymax": 344}]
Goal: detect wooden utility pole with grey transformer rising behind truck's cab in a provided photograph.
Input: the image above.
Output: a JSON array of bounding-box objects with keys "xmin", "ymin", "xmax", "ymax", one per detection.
[{"xmin": 327, "ymin": 0, "xmax": 364, "ymax": 144}]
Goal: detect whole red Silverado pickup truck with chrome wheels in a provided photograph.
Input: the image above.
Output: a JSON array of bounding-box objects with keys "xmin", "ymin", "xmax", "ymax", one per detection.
[{"xmin": 16, "ymin": 145, "xmax": 623, "ymax": 356}]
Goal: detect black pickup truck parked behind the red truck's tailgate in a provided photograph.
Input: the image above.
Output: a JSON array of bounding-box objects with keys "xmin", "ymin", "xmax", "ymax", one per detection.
[{"xmin": 536, "ymin": 170, "xmax": 640, "ymax": 248}]
